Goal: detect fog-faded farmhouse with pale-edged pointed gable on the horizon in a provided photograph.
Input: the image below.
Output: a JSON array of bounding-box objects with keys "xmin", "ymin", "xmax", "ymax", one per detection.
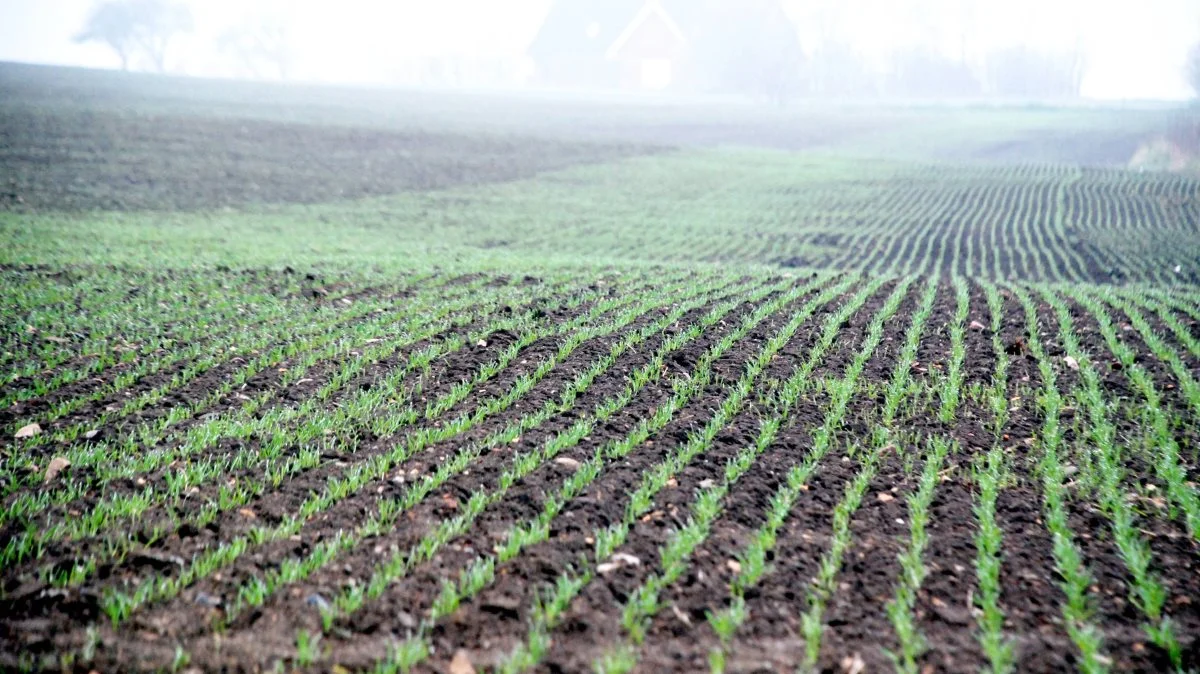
[{"xmin": 529, "ymin": 0, "xmax": 703, "ymax": 91}]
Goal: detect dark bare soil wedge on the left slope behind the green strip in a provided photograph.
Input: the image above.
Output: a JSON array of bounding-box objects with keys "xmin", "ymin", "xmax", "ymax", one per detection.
[{"xmin": 0, "ymin": 103, "xmax": 662, "ymax": 211}]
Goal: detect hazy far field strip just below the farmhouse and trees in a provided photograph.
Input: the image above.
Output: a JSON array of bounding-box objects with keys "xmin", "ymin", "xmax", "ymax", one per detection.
[{"xmin": 0, "ymin": 64, "xmax": 1174, "ymax": 167}]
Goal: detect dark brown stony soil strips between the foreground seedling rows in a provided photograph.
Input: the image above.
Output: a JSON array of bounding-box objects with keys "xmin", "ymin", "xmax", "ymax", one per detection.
[{"xmin": 0, "ymin": 279, "xmax": 1200, "ymax": 673}]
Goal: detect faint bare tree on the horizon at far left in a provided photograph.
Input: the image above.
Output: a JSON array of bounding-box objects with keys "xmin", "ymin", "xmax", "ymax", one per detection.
[{"xmin": 74, "ymin": 0, "xmax": 192, "ymax": 72}]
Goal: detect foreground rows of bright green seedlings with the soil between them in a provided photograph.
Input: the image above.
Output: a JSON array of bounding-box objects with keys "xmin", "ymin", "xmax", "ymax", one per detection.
[{"xmin": 0, "ymin": 269, "xmax": 1200, "ymax": 674}]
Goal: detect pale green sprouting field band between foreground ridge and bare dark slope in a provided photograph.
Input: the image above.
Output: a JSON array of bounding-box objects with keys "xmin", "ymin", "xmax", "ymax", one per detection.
[{"xmin": 0, "ymin": 146, "xmax": 1200, "ymax": 287}]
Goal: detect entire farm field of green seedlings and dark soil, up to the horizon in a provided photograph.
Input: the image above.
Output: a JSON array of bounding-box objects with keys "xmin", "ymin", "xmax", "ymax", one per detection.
[{"xmin": 0, "ymin": 60, "xmax": 1200, "ymax": 674}]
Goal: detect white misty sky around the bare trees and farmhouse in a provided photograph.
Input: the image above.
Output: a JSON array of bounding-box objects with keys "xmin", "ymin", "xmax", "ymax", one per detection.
[{"xmin": 0, "ymin": 0, "xmax": 1200, "ymax": 98}]
